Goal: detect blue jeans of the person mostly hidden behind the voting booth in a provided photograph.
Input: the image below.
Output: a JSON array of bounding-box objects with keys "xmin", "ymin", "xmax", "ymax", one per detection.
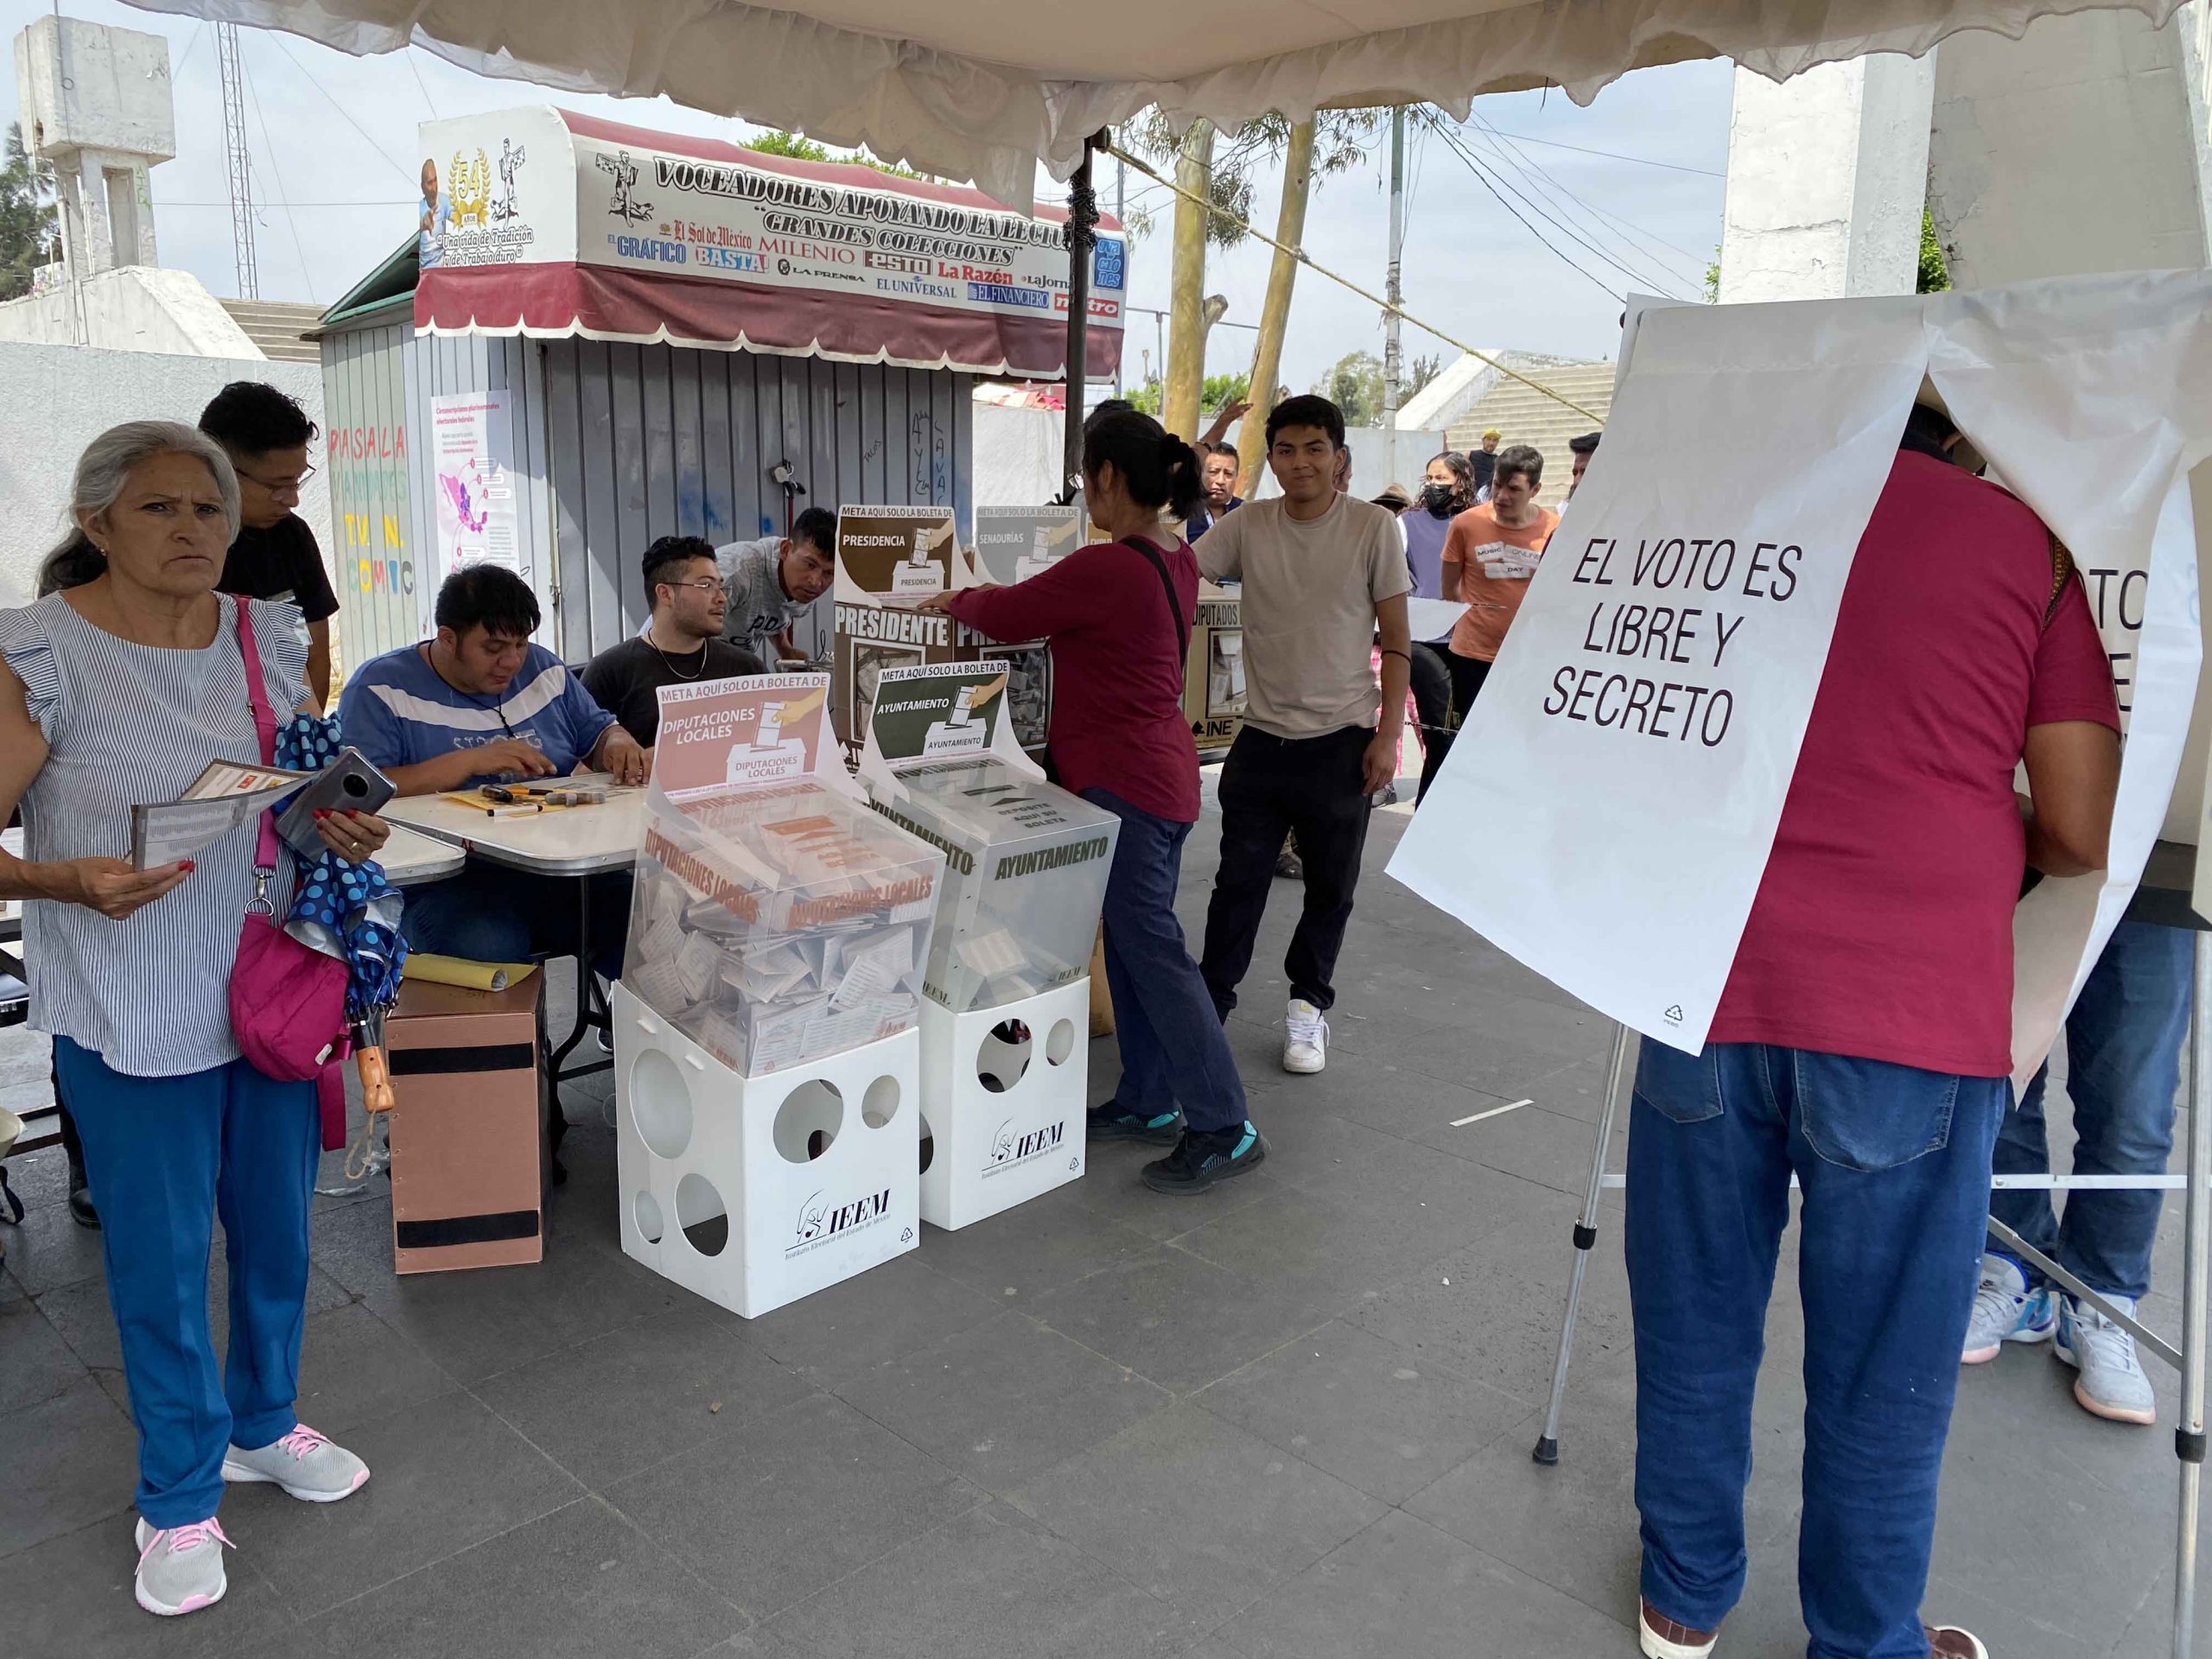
[{"xmin": 1988, "ymin": 923, "xmax": 2190, "ymax": 1296}]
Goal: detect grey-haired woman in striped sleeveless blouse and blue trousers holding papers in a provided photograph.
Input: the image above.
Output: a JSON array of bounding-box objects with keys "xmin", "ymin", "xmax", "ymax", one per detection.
[{"xmin": 0, "ymin": 420, "xmax": 387, "ymax": 1615}]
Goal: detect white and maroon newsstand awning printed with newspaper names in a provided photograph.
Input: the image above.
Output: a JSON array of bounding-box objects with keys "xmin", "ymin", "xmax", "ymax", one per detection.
[{"xmin": 414, "ymin": 108, "xmax": 1126, "ymax": 380}]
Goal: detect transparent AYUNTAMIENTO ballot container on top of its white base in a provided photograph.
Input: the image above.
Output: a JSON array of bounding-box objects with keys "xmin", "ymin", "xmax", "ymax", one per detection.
[{"xmin": 876, "ymin": 754, "xmax": 1122, "ymax": 1013}]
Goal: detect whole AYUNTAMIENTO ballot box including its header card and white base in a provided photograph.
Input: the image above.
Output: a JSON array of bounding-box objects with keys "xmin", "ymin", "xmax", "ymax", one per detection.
[{"xmin": 861, "ymin": 661, "xmax": 1122, "ymax": 1228}]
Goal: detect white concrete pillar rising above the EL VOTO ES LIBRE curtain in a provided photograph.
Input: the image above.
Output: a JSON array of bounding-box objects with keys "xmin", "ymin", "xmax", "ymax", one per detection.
[{"xmin": 1721, "ymin": 55, "xmax": 1936, "ymax": 303}]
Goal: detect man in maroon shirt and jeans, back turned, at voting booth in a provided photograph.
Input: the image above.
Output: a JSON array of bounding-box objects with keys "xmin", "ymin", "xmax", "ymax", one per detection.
[{"xmin": 1624, "ymin": 410, "xmax": 2119, "ymax": 1659}]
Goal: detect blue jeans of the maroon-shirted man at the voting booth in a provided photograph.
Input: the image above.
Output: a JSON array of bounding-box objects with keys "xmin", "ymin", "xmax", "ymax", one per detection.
[{"xmin": 1626, "ymin": 1042, "xmax": 2011, "ymax": 1659}]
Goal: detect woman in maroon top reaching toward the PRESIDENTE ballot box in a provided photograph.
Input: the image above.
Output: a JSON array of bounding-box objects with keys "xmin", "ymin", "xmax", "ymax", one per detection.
[{"xmin": 927, "ymin": 410, "xmax": 1268, "ymax": 1192}]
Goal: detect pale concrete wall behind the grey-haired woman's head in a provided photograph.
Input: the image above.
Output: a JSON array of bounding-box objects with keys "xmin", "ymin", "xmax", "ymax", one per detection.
[{"xmin": 0, "ymin": 340, "xmax": 332, "ymax": 606}]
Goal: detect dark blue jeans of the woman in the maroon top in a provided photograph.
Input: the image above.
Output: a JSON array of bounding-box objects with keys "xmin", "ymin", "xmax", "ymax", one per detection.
[{"xmin": 1082, "ymin": 790, "xmax": 1245, "ymax": 1130}]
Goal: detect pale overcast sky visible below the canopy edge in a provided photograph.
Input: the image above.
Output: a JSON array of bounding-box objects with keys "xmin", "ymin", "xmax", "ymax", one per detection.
[{"xmin": 0, "ymin": 0, "xmax": 1730, "ymax": 387}]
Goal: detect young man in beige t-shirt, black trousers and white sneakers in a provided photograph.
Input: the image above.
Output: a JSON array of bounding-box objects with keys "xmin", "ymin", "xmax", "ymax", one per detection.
[{"xmin": 1192, "ymin": 398, "xmax": 1411, "ymax": 1073}]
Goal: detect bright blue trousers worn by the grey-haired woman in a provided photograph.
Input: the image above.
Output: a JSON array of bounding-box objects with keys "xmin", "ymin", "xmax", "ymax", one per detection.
[{"xmin": 53, "ymin": 1038, "xmax": 323, "ymax": 1526}]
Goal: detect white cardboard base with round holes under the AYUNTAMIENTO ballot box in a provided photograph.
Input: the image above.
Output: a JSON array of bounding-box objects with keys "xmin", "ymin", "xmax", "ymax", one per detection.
[{"xmin": 920, "ymin": 978, "xmax": 1090, "ymax": 1230}]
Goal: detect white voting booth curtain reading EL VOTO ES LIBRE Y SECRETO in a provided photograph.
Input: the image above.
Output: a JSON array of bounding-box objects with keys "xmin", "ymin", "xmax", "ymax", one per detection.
[{"xmin": 1389, "ymin": 301, "xmax": 1927, "ymax": 1053}]
